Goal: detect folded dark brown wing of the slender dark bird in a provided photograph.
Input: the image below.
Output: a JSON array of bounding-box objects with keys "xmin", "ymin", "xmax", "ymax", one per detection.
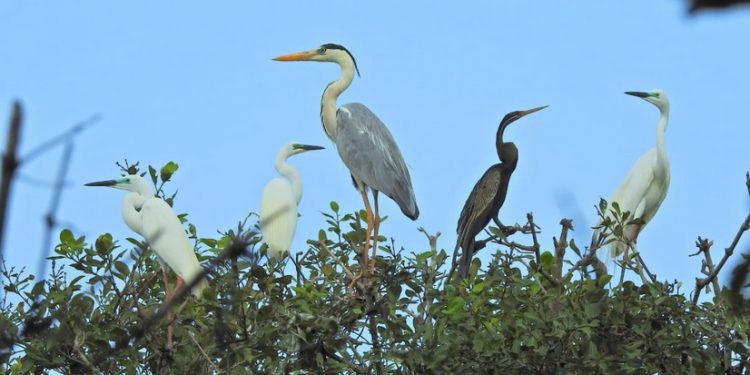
[{"xmin": 456, "ymin": 164, "xmax": 503, "ymax": 250}]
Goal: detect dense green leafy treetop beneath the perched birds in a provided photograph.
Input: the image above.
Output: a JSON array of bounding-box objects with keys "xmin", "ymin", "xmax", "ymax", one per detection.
[{"xmin": 0, "ymin": 171, "xmax": 750, "ymax": 374}]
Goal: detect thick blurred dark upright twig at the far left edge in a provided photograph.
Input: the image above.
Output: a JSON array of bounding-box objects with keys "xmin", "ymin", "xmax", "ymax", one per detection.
[{"xmin": 0, "ymin": 101, "xmax": 23, "ymax": 260}]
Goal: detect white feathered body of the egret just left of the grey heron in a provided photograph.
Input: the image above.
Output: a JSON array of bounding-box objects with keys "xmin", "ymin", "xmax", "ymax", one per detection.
[{"xmin": 260, "ymin": 177, "xmax": 297, "ymax": 259}]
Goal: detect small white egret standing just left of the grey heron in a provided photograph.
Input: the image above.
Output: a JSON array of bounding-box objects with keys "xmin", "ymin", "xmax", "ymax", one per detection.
[{"xmin": 260, "ymin": 142, "xmax": 323, "ymax": 259}]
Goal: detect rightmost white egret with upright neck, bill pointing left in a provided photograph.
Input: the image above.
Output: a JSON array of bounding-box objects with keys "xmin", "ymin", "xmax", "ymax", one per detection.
[{"xmin": 595, "ymin": 90, "xmax": 670, "ymax": 257}]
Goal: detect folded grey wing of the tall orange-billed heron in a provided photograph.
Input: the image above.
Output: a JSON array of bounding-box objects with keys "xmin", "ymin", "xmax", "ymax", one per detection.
[{"xmin": 336, "ymin": 103, "xmax": 419, "ymax": 220}]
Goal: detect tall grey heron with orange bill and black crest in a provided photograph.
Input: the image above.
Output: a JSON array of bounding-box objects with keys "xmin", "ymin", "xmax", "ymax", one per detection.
[{"xmin": 274, "ymin": 43, "xmax": 419, "ymax": 276}]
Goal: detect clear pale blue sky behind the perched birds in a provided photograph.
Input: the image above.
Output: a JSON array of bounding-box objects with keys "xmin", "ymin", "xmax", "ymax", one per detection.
[{"xmin": 0, "ymin": 0, "xmax": 750, "ymax": 290}]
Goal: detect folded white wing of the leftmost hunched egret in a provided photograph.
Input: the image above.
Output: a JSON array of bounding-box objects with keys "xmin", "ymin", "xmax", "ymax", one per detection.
[{"xmin": 141, "ymin": 198, "xmax": 205, "ymax": 296}]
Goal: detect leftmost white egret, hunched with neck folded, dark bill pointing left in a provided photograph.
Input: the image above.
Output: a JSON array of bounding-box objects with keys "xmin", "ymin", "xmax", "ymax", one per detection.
[{"xmin": 86, "ymin": 175, "xmax": 207, "ymax": 299}]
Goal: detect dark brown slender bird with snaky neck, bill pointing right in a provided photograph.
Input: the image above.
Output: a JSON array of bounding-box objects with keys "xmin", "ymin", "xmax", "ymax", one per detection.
[{"xmin": 451, "ymin": 105, "xmax": 547, "ymax": 279}]
